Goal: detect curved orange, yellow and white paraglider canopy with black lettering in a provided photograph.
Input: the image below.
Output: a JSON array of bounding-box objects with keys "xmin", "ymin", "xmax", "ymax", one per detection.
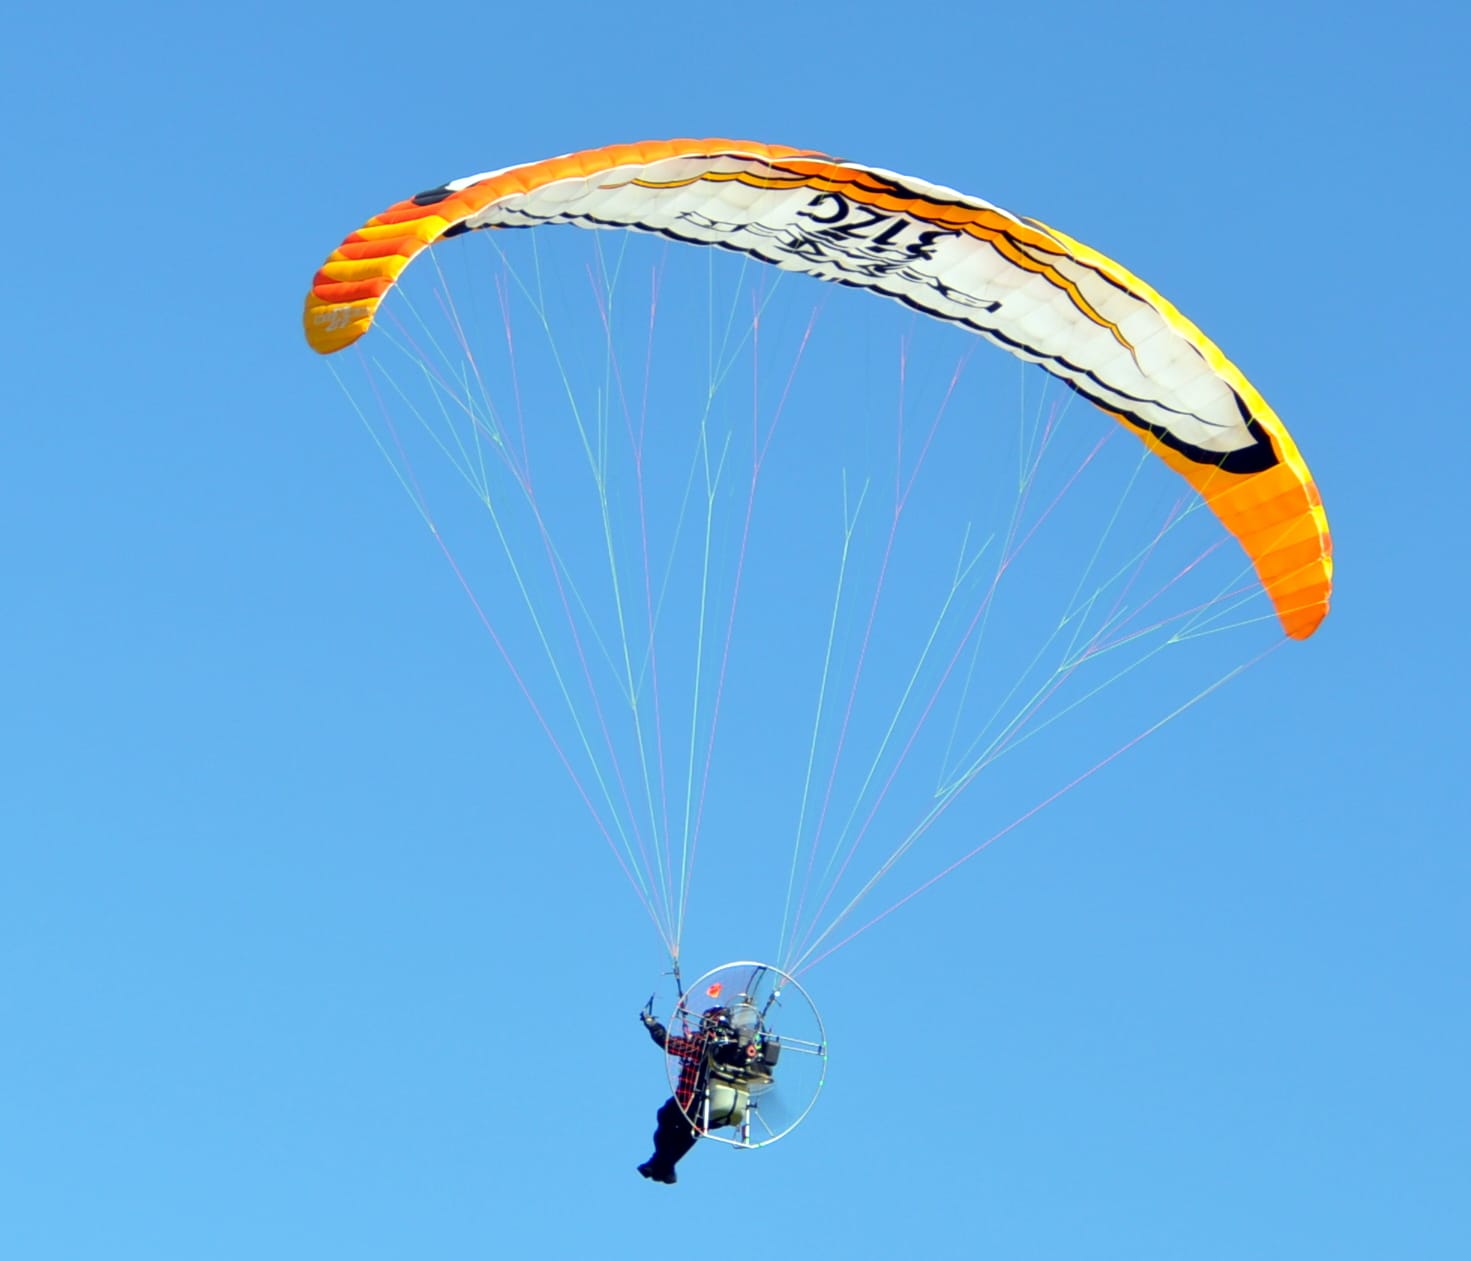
[{"xmin": 304, "ymin": 140, "xmax": 1333, "ymax": 639}]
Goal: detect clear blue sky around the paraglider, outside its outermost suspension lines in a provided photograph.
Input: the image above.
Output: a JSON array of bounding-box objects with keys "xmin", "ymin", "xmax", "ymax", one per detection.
[{"xmin": 0, "ymin": 4, "xmax": 1471, "ymax": 1261}]
